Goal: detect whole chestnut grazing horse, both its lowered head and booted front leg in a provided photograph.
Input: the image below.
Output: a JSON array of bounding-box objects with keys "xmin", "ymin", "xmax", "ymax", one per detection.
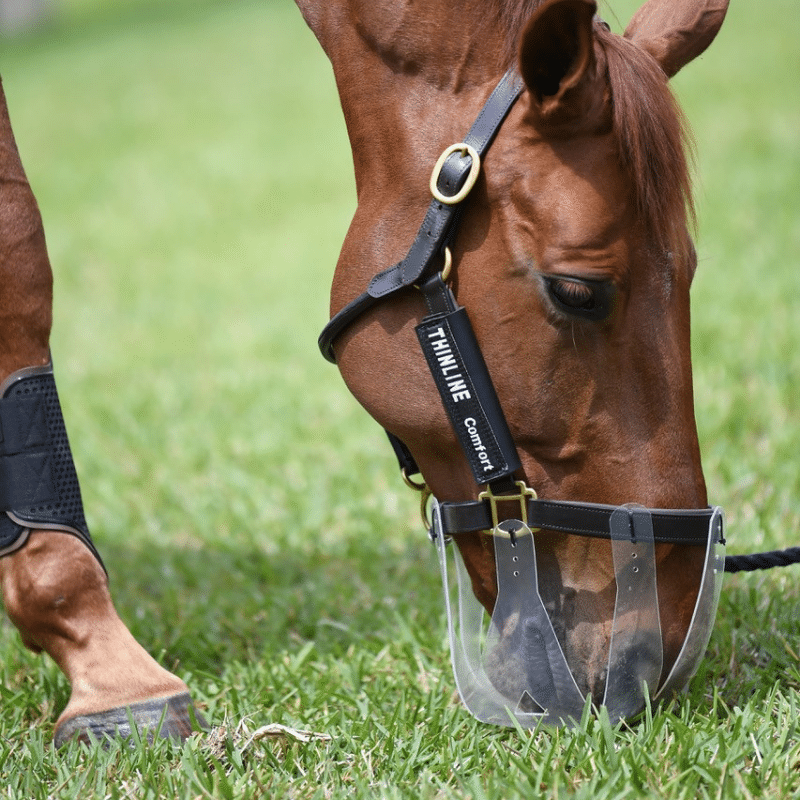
[{"xmin": 0, "ymin": 0, "xmax": 727, "ymax": 745}]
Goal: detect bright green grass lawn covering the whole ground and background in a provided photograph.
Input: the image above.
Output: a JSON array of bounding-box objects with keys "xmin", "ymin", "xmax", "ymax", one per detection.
[{"xmin": 0, "ymin": 0, "xmax": 800, "ymax": 800}]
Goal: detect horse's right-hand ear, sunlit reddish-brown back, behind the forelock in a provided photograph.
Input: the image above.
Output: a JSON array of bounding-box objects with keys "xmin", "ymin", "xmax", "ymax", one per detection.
[{"xmin": 625, "ymin": 0, "xmax": 728, "ymax": 78}]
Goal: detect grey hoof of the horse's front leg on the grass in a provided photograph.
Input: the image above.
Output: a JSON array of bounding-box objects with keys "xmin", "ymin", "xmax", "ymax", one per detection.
[{"xmin": 53, "ymin": 692, "xmax": 208, "ymax": 747}]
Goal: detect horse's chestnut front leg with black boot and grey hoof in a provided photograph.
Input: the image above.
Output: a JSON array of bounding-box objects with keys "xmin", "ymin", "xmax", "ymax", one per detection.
[{"xmin": 0, "ymin": 78, "xmax": 204, "ymax": 744}]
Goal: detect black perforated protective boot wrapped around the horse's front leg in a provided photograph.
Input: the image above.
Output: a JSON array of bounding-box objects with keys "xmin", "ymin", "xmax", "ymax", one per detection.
[{"xmin": 0, "ymin": 364, "xmax": 105, "ymax": 568}]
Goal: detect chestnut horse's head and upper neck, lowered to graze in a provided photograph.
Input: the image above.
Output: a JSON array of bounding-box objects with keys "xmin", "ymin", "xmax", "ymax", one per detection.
[{"xmin": 298, "ymin": 0, "xmax": 727, "ymax": 716}]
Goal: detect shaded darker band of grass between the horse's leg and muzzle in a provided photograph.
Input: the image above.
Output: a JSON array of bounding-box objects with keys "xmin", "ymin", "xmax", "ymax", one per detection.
[{"xmin": 97, "ymin": 541, "xmax": 442, "ymax": 673}]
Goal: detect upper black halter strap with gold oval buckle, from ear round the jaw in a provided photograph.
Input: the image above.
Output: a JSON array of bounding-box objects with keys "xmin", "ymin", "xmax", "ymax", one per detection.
[{"xmin": 319, "ymin": 70, "xmax": 524, "ymax": 363}]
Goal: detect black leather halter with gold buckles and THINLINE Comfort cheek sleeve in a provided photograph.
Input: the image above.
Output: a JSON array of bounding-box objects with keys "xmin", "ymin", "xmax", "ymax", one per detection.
[{"xmin": 319, "ymin": 70, "xmax": 713, "ymax": 546}]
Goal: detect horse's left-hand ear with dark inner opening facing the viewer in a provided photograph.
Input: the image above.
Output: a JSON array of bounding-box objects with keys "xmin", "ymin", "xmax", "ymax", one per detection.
[{"xmin": 519, "ymin": 0, "xmax": 597, "ymax": 124}]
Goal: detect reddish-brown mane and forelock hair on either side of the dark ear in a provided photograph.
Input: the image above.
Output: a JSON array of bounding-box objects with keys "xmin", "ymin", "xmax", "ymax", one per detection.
[{"xmin": 490, "ymin": 0, "xmax": 696, "ymax": 253}]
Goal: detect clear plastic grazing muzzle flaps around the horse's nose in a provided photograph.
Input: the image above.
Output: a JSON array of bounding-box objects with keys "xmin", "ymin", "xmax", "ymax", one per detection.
[{"xmin": 432, "ymin": 502, "xmax": 725, "ymax": 728}]
